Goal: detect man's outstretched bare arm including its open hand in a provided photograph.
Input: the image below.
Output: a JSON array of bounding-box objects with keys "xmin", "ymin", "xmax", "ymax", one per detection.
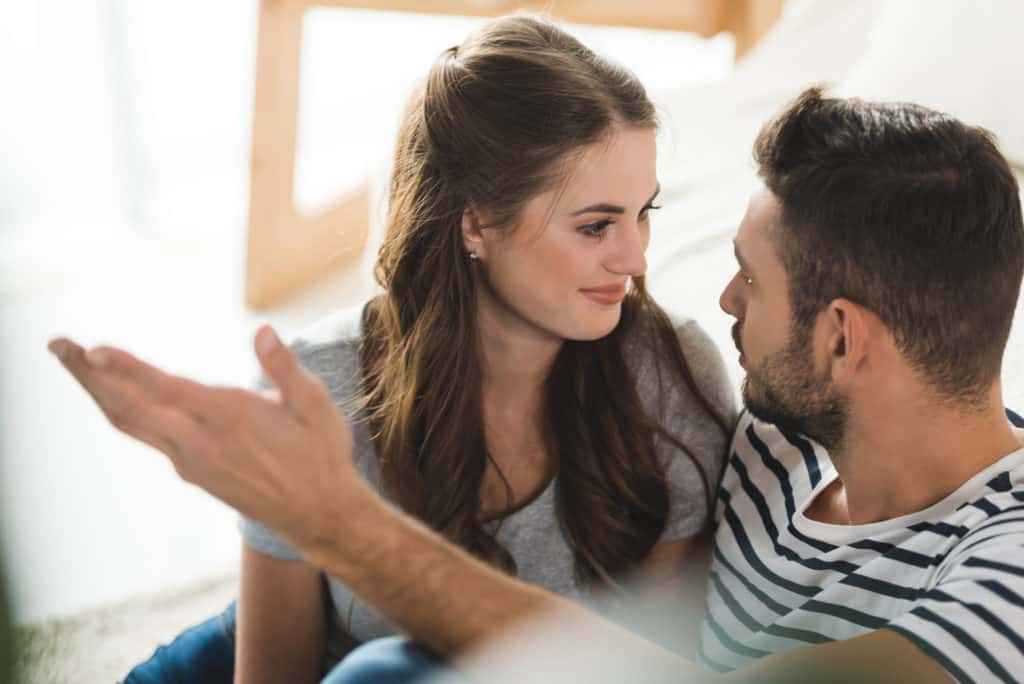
[{"xmin": 50, "ymin": 329, "xmax": 946, "ymax": 682}]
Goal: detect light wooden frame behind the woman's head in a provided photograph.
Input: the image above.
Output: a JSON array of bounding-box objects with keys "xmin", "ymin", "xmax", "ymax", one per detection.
[{"xmin": 246, "ymin": 0, "xmax": 782, "ymax": 309}]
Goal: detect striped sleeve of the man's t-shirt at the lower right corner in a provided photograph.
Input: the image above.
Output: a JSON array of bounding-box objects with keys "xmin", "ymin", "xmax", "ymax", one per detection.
[{"xmin": 887, "ymin": 528, "xmax": 1024, "ymax": 682}]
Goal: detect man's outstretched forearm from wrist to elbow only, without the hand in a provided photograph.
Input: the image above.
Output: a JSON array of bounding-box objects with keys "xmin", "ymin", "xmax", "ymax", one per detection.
[{"xmin": 302, "ymin": 487, "xmax": 716, "ymax": 682}]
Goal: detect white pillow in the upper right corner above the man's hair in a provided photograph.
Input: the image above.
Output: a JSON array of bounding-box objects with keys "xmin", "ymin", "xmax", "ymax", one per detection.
[{"xmin": 836, "ymin": 0, "xmax": 1024, "ymax": 168}]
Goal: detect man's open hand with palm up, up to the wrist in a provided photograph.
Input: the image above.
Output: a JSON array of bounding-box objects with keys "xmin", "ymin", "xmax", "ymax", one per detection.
[{"xmin": 49, "ymin": 327, "xmax": 361, "ymax": 550}]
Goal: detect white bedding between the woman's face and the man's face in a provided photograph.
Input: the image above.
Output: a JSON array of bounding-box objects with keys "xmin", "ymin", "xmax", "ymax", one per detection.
[{"xmin": 648, "ymin": 0, "xmax": 1024, "ymax": 412}]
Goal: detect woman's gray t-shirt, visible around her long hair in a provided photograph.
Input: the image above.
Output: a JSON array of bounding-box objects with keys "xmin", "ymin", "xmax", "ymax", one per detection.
[{"xmin": 240, "ymin": 306, "xmax": 735, "ymax": 641}]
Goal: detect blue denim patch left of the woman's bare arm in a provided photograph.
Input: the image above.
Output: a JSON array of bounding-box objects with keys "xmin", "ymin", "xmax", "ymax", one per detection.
[{"xmin": 124, "ymin": 601, "xmax": 236, "ymax": 684}]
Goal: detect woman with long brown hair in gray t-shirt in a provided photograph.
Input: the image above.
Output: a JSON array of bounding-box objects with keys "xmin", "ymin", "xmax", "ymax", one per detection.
[{"xmin": 72, "ymin": 15, "xmax": 733, "ymax": 682}]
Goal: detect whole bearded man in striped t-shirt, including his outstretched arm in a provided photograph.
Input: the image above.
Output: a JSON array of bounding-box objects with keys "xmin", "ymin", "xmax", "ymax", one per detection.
[{"xmin": 51, "ymin": 90, "xmax": 1024, "ymax": 682}]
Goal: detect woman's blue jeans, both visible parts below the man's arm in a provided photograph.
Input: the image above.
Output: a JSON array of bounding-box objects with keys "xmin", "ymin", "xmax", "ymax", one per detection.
[{"xmin": 124, "ymin": 601, "xmax": 461, "ymax": 684}]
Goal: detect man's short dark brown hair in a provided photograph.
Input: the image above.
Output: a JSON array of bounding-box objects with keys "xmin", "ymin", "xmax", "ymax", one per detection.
[{"xmin": 754, "ymin": 88, "xmax": 1024, "ymax": 405}]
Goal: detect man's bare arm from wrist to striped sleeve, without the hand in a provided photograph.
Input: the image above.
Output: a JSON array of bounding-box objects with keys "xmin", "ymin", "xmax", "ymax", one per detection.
[{"xmin": 302, "ymin": 487, "xmax": 949, "ymax": 684}]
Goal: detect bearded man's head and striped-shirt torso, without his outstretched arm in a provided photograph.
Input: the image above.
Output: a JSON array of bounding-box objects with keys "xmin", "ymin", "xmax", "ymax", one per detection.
[{"xmin": 701, "ymin": 90, "xmax": 1024, "ymax": 681}]
